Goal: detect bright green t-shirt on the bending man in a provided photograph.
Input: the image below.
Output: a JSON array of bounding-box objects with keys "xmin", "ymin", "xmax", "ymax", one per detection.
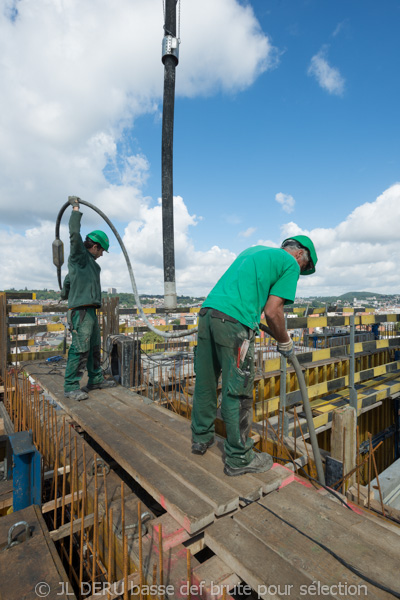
[{"xmin": 203, "ymin": 246, "xmax": 300, "ymax": 331}]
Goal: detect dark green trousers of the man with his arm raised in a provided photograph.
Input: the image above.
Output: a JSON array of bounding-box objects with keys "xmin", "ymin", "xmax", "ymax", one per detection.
[{"xmin": 64, "ymin": 306, "xmax": 104, "ymax": 392}]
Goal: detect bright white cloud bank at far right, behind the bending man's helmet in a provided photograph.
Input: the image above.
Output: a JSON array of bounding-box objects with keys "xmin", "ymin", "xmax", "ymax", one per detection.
[{"xmin": 281, "ymin": 183, "xmax": 400, "ymax": 296}]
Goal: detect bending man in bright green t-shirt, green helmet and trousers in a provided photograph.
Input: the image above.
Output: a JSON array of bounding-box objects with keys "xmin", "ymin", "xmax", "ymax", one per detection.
[{"xmin": 192, "ymin": 235, "xmax": 317, "ymax": 476}]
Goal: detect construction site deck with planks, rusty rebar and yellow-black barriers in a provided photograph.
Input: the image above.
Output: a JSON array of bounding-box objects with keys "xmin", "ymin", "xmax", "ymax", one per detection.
[{"xmin": 0, "ymin": 294, "xmax": 400, "ymax": 600}]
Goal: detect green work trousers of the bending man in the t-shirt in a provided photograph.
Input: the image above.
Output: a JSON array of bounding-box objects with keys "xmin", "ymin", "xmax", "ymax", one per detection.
[{"xmin": 192, "ymin": 308, "xmax": 255, "ymax": 468}]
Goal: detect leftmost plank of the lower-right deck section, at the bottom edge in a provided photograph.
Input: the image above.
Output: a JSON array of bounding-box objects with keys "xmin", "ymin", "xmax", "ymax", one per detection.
[{"xmin": 204, "ymin": 517, "xmax": 322, "ymax": 600}]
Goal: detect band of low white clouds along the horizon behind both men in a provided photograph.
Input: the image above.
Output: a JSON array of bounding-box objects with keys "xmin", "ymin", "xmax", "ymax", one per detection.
[{"xmin": 0, "ymin": 183, "xmax": 400, "ymax": 296}]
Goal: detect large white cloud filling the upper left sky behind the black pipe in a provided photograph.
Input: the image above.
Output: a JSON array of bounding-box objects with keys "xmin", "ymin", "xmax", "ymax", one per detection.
[{"xmin": 0, "ymin": 0, "xmax": 276, "ymax": 228}]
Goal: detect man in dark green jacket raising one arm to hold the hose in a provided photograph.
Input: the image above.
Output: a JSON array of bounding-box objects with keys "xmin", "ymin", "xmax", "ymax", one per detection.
[{"xmin": 61, "ymin": 196, "xmax": 116, "ymax": 401}]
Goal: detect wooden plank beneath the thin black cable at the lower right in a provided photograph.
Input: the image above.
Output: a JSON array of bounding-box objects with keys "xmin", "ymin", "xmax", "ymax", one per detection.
[{"xmin": 233, "ymin": 486, "xmax": 390, "ymax": 600}]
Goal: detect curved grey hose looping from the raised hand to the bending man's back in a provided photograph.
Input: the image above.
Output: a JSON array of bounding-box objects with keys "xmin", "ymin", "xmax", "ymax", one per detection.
[{"xmin": 56, "ymin": 199, "xmax": 197, "ymax": 338}]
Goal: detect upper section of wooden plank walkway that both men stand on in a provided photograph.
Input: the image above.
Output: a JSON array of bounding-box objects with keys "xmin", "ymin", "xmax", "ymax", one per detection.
[{"xmin": 22, "ymin": 363, "xmax": 290, "ymax": 534}]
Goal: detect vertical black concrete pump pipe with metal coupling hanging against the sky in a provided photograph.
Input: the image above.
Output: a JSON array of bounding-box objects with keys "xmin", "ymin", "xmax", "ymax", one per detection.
[{"xmin": 161, "ymin": 0, "xmax": 179, "ymax": 309}]
